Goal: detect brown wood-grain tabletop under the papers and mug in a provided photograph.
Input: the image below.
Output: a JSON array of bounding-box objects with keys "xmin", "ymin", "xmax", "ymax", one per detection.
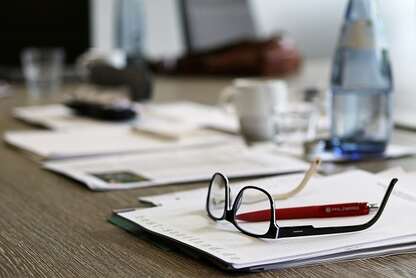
[{"xmin": 0, "ymin": 59, "xmax": 416, "ymax": 277}]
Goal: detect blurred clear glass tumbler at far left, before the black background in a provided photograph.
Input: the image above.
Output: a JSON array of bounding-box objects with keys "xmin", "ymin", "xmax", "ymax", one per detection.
[{"xmin": 21, "ymin": 48, "xmax": 65, "ymax": 100}]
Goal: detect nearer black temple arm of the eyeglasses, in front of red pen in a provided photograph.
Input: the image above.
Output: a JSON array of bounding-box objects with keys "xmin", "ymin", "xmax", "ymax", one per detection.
[{"xmin": 278, "ymin": 178, "xmax": 398, "ymax": 238}]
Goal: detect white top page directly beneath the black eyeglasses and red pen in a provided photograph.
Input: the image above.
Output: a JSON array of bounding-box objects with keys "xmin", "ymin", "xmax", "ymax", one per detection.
[{"xmin": 119, "ymin": 173, "xmax": 416, "ymax": 268}]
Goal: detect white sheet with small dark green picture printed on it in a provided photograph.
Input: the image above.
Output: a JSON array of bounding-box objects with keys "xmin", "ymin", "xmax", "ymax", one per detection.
[{"xmin": 44, "ymin": 143, "xmax": 308, "ymax": 190}]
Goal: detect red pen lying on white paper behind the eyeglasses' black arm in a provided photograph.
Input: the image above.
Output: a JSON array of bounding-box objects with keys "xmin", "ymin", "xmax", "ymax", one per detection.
[{"xmin": 236, "ymin": 203, "xmax": 378, "ymax": 222}]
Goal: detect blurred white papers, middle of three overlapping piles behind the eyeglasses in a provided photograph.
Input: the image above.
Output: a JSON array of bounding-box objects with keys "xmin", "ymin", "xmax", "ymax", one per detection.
[{"xmin": 4, "ymin": 127, "xmax": 240, "ymax": 160}]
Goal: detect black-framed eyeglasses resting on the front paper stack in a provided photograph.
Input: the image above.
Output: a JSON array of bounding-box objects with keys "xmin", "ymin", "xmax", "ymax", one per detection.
[{"xmin": 206, "ymin": 165, "xmax": 398, "ymax": 239}]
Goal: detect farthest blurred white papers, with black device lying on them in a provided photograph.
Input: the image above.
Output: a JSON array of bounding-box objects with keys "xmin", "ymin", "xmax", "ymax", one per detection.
[{"xmin": 13, "ymin": 102, "xmax": 239, "ymax": 134}]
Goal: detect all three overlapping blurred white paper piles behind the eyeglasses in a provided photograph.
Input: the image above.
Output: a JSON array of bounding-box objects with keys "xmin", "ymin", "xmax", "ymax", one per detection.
[{"xmin": 9, "ymin": 102, "xmax": 308, "ymax": 190}]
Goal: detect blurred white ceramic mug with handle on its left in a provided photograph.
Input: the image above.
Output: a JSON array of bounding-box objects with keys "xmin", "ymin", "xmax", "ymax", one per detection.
[{"xmin": 220, "ymin": 79, "xmax": 288, "ymax": 142}]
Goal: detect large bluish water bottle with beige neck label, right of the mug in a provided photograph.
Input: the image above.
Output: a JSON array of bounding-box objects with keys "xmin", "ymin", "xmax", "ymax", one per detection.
[{"xmin": 331, "ymin": 0, "xmax": 393, "ymax": 156}]
